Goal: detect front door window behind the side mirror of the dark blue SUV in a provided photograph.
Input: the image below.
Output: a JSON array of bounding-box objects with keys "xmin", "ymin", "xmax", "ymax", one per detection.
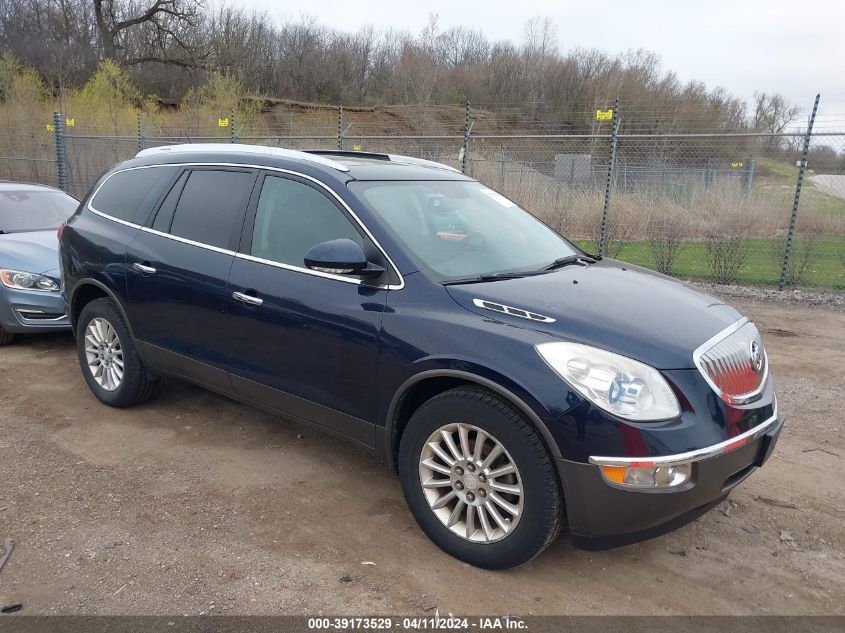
[{"xmin": 252, "ymin": 176, "xmax": 364, "ymax": 267}]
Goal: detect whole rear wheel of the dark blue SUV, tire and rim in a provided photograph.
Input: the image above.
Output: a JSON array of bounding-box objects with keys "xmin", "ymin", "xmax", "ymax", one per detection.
[{"xmin": 76, "ymin": 298, "xmax": 157, "ymax": 407}]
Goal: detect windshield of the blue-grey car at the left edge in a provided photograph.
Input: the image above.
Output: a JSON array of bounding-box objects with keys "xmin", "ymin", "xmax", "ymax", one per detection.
[{"xmin": 0, "ymin": 190, "xmax": 79, "ymax": 233}]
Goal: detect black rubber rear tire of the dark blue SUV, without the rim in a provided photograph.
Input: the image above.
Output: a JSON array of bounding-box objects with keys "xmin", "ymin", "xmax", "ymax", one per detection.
[{"xmin": 76, "ymin": 298, "xmax": 158, "ymax": 408}]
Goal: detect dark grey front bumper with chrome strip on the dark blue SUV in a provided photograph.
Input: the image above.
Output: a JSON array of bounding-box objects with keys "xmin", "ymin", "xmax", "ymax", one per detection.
[{"xmin": 557, "ymin": 415, "xmax": 783, "ymax": 550}]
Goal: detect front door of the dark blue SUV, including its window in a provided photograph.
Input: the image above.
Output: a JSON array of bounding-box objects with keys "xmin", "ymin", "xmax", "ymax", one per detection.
[{"xmin": 228, "ymin": 174, "xmax": 387, "ymax": 445}]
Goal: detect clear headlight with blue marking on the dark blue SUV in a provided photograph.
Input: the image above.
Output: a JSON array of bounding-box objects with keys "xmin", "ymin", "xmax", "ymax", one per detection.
[{"xmin": 537, "ymin": 342, "xmax": 681, "ymax": 421}]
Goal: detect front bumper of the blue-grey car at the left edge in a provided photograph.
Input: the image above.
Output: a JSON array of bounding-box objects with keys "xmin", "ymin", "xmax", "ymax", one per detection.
[{"xmin": 0, "ymin": 287, "xmax": 70, "ymax": 334}]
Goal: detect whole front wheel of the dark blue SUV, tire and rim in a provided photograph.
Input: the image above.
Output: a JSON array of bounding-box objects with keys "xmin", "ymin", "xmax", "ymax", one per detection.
[{"xmin": 399, "ymin": 388, "xmax": 561, "ymax": 569}]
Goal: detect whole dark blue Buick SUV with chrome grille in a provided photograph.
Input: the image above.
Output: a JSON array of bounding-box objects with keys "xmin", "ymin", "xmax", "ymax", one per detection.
[{"xmin": 61, "ymin": 145, "xmax": 782, "ymax": 568}]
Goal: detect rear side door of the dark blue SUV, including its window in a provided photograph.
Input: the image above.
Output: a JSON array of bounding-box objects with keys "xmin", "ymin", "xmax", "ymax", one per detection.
[{"xmin": 126, "ymin": 167, "xmax": 256, "ymax": 391}]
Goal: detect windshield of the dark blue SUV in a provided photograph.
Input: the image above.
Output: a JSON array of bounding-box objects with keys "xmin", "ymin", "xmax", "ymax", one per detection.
[{"xmin": 349, "ymin": 181, "xmax": 581, "ymax": 281}]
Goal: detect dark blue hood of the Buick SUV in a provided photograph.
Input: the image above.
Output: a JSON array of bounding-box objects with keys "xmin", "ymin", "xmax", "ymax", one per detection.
[{"xmin": 446, "ymin": 259, "xmax": 742, "ymax": 369}]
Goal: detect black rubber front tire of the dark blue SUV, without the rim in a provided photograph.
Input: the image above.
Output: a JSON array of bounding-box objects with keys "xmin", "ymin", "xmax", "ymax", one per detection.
[{"xmin": 398, "ymin": 387, "xmax": 562, "ymax": 569}]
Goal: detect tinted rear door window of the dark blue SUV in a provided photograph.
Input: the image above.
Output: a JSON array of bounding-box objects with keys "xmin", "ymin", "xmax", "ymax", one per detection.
[{"xmin": 170, "ymin": 170, "xmax": 254, "ymax": 248}]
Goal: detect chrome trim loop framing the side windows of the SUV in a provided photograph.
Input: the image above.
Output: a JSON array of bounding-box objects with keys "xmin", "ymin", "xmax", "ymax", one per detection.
[{"xmin": 86, "ymin": 163, "xmax": 405, "ymax": 290}]
